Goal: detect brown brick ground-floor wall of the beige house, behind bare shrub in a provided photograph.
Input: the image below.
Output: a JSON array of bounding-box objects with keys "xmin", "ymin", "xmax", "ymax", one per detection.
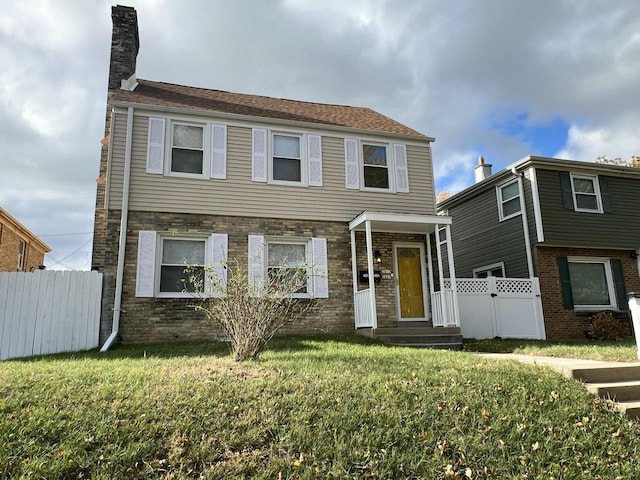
[{"xmin": 101, "ymin": 211, "xmax": 354, "ymax": 343}]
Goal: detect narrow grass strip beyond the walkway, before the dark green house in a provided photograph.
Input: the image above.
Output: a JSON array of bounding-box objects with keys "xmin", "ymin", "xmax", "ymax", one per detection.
[{"xmin": 464, "ymin": 338, "xmax": 638, "ymax": 362}]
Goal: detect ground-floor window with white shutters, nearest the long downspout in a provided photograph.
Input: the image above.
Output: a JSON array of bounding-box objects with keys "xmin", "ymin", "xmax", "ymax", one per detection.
[{"xmin": 136, "ymin": 230, "xmax": 227, "ymax": 298}]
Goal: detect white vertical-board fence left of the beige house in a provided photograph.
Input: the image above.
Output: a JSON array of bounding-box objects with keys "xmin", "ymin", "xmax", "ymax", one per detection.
[{"xmin": 0, "ymin": 271, "xmax": 102, "ymax": 360}]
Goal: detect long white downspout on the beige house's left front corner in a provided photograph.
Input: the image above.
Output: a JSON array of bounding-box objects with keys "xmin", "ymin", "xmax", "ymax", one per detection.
[{"xmin": 100, "ymin": 107, "xmax": 133, "ymax": 352}]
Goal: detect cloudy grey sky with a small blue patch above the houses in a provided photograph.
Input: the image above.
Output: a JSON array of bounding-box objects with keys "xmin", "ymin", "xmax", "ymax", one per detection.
[{"xmin": 0, "ymin": 0, "xmax": 640, "ymax": 270}]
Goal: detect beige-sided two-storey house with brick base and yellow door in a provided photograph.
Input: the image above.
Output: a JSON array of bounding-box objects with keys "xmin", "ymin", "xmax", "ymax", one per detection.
[{"xmin": 93, "ymin": 6, "xmax": 457, "ymax": 348}]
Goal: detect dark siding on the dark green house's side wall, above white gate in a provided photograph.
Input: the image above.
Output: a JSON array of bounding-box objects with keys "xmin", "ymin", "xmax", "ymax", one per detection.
[{"xmin": 448, "ymin": 179, "xmax": 533, "ymax": 278}]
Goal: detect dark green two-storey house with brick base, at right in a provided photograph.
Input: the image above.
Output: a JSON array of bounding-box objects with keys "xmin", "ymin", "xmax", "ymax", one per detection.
[{"xmin": 438, "ymin": 156, "xmax": 640, "ymax": 339}]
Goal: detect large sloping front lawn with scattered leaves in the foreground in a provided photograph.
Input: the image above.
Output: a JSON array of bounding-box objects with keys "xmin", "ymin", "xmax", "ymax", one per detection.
[{"xmin": 0, "ymin": 336, "xmax": 640, "ymax": 479}]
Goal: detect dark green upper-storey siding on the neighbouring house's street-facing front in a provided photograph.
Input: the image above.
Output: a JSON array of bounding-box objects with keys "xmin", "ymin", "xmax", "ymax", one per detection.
[{"xmin": 536, "ymin": 168, "xmax": 640, "ymax": 249}]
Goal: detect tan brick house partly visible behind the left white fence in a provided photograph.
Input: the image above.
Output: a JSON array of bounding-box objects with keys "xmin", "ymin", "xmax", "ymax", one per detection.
[{"xmin": 0, "ymin": 207, "xmax": 51, "ymax": 272}]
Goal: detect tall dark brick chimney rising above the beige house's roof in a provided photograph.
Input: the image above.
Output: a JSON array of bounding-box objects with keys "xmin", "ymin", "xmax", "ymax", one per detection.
[{"xmin": 109, "ymin": 5, "xmax": 140, "ymax": 90}]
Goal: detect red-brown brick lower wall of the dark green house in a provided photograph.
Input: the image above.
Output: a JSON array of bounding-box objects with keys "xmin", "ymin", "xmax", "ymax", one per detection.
[{"xmin": 534, "ymin": 246, "xmax": 640, "ymax": 340}]
